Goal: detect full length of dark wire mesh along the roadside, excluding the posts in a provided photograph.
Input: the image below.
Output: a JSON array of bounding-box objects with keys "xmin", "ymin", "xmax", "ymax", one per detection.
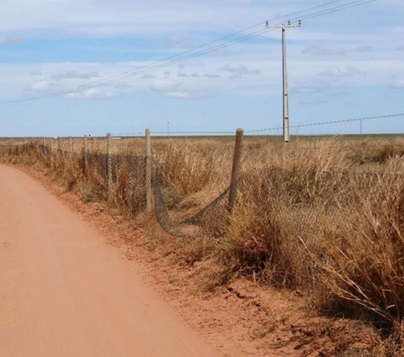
[{"xmin": 0, "ymin": 138, "xmax": 404, "ymax": 239}]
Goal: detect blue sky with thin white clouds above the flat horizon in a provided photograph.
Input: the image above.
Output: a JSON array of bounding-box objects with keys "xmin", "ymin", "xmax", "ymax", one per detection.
[{"xmin": 0, "ymin": 0, "xmax": 404, "ymax": 136}]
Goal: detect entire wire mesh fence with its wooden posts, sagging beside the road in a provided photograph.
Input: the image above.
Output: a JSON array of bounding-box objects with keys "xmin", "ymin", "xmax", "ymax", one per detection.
[{"xmin": 0, "ymin": 134, "xmax": 404, "ymax": 245}]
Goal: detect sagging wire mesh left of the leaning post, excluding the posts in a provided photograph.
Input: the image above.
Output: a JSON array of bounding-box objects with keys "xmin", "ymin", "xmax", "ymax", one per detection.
[{"xmin": 32, "ymin": 145, "xmax": 236, "ymax": 237}]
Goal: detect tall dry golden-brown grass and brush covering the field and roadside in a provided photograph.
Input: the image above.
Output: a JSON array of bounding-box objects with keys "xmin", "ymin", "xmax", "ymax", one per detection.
[{"xmin": 2, "ymin": 137, "xmax": 404, "ymax": 356}]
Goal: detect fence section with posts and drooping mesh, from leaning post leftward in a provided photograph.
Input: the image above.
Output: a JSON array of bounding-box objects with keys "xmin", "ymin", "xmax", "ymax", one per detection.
[{"xmin": 0, "ymin": 129, "xmax": 243, "ymax": 237}]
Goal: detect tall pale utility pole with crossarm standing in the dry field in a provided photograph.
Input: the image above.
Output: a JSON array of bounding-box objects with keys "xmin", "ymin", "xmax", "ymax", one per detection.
[{"xmin": 266, "ymin": 20, "xmax": 302, "ymax": 143}]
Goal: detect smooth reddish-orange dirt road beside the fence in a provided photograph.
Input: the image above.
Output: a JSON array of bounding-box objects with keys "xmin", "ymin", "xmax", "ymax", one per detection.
[{"xmin": 0, "ymin": 165, "xmax": 221, "ymax": 357}]
